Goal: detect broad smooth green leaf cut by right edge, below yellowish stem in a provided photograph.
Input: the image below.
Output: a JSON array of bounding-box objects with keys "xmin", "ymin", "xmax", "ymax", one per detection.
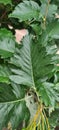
[{"xmin": 39, "ymin": 21, "xmax": 59, "ymax": 46}]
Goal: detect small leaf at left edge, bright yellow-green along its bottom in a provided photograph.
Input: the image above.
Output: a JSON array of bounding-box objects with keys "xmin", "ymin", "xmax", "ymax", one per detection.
[{"xmin": 0, "ymin": 65, "xmax": 9, "ymax": 83}]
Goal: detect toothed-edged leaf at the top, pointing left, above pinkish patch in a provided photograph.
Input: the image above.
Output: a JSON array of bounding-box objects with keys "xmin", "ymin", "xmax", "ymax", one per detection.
[{"xmin": 9, "ymin": 0, "xmax": 40, "ymax": 21}]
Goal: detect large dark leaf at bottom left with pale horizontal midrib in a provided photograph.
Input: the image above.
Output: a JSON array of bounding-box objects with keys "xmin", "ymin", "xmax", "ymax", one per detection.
[{"xmin": 0, "ymin": 84, "xmax": 30, "ymax": 130}]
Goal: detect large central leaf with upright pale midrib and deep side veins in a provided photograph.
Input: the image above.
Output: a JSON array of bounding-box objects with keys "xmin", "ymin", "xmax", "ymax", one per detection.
[{"xmin": 10, "ymin": 35, "xmax": 53, "ymax": 87}]
